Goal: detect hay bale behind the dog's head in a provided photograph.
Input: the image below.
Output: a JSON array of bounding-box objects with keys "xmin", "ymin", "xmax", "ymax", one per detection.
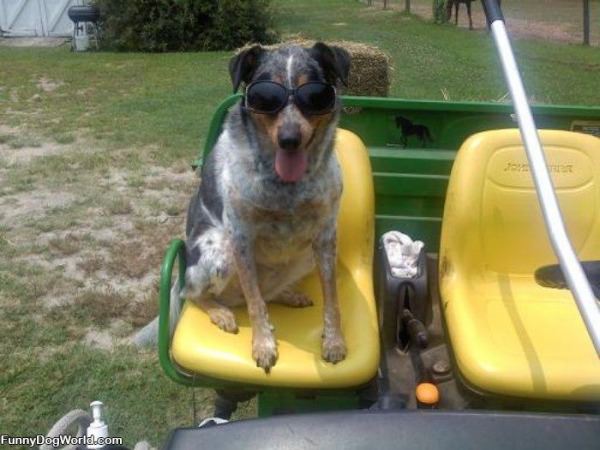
[{"xmin": 238, "ymin": 38, "xmax": 391, "ymax": 97}]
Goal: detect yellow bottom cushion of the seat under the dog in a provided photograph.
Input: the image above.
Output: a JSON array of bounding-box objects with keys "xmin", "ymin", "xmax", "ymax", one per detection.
[{"xmin": 172, "ymin": 266, "xmax": 379, "ymax": 388}]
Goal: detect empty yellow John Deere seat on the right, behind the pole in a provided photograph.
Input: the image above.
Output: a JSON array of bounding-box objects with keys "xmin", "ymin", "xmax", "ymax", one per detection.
[{"xmin": 440, "ymin": 129, "xmax": 600, "ymax": 401}]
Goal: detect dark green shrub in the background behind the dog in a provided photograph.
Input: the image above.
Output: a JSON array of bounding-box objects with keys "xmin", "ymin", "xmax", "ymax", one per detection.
[{"xmin": 94, "ymin": 0, "xmax": 276, "ymax": 52}]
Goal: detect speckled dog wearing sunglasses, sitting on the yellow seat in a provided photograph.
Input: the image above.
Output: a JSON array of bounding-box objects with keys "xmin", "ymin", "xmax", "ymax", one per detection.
[{"xmin": 182, "ymin": 42, "xmax": 350, "ymax": 373}]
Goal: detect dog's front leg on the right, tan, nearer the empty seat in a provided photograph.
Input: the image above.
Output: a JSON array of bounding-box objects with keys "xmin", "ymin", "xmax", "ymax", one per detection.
[{"xmin": 313, "ymin": 222, "xmax": 346, "ymax": 364}]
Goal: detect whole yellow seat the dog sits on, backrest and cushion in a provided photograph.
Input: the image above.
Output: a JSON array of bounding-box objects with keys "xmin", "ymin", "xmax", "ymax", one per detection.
[{"xmin": 171, "ymin": 129, "xmax": 379, "ymax": 388}]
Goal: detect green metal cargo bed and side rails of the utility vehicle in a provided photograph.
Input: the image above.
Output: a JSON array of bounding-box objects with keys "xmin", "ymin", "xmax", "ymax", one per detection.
[{"xmin": 159, "ymin": 94, "xmax": 600, "ymax": 408}]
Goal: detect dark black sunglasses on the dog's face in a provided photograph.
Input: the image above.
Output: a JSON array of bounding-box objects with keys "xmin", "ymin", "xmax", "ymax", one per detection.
[{"xmin": 244, "ymin": 80, "xmax": 335, "ymax": 115}]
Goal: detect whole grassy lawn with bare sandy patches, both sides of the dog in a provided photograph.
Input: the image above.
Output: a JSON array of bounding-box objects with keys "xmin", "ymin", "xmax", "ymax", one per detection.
[{"xmin": 0, "ymin": 0, "xmax": 600, "ymax": 445}]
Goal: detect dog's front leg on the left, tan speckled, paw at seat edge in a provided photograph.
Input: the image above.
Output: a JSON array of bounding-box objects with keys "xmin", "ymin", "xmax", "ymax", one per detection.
[{"xmin": 231, "ymin": 226, "xmax": 277, "ymax": 373}]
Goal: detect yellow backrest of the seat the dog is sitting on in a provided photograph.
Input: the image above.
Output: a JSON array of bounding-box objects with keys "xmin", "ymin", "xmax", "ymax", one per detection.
[{"xmin": 335, "ymin": 129, "xmax": 375, "ymax": 271}]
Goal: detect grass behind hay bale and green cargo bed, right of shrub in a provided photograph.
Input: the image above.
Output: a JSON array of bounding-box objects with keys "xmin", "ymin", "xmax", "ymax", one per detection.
[{"xmin": 278, "ymin": 0, "xmax": 600, "ymax": 105}]
